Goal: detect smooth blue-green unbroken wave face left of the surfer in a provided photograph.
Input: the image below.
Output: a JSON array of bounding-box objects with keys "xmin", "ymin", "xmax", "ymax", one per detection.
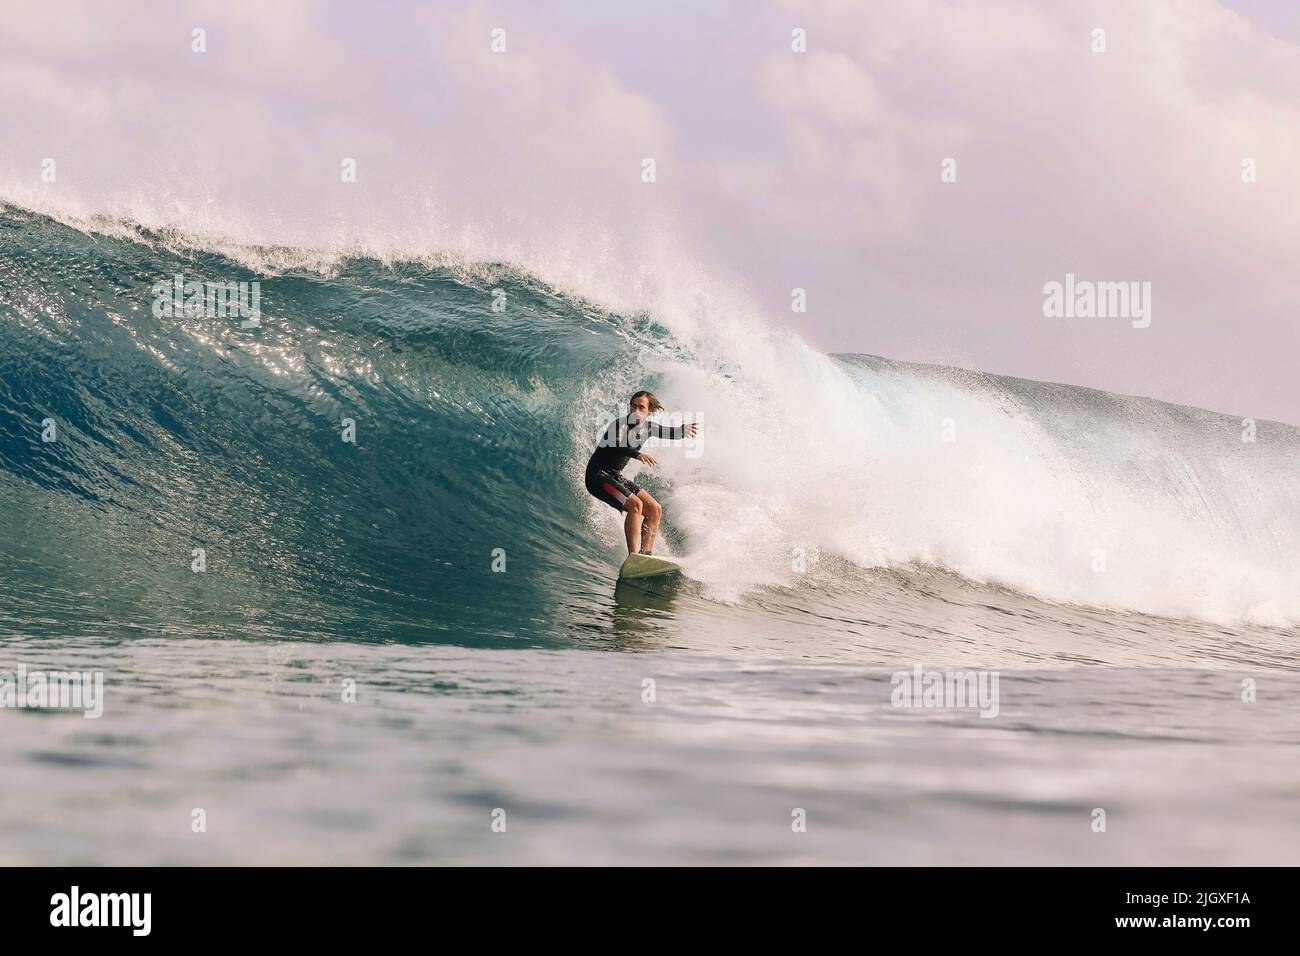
[{"xmin": 0, "ymin": 209, "xmax": 644, "ymax": 643}]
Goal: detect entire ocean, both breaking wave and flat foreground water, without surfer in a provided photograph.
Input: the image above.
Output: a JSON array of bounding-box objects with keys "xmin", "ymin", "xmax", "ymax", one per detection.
[{"xmin": 0, "ymin": 207, "xmax": 1300, "ymax": 865}]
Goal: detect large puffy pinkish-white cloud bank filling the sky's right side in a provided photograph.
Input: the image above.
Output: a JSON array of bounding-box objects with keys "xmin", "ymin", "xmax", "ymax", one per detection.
[{"xmin": 754, "ymin": 0, "xmax": 1300, "ymax": 420}]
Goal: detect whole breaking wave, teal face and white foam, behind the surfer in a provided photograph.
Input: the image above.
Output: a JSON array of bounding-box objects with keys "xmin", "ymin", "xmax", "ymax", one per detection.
[{"xmin": 0, "ymin": 207, "xmax": 1300, "ymax": 640}]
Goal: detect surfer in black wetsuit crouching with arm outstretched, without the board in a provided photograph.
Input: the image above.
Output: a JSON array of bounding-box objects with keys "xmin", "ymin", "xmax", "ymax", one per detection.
[{"xmin": 585, "ymin": 392, "xmax": 696, "ymax": 554}]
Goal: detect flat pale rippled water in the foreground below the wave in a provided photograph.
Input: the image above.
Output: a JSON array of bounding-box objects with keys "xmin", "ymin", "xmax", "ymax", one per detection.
[{"xmin": 0, "ymin": 639, "xmax": 1300, "ymax": 865}]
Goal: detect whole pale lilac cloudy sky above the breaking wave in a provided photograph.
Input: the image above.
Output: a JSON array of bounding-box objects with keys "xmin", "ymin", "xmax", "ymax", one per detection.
[{"xmin": 0, "ymin": 0, "xmax": 1300, "ymax": 424}]
